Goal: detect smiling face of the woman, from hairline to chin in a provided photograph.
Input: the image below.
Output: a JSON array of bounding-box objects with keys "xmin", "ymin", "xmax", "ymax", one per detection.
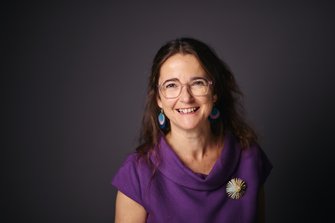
[{"xmin": 157, "ymin": 54, "xmax": 216, "ymax": 131}]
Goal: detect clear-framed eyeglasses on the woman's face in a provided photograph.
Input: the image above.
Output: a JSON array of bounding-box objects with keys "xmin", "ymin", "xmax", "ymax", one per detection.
[{"xmin": 158, "ymin": 78, "xmax": 213, "ymax": 99}]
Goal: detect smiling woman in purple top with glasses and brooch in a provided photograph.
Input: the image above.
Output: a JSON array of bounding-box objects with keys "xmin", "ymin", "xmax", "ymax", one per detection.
[{"xmin": 112, "ymin": 38, "xmax": 272, "ymax": 223}]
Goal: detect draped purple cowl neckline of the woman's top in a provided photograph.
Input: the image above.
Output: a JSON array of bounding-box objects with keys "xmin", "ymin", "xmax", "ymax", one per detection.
[{"xmin": 150, "ymin": 133, "xmax": 241, "ymax": 190}]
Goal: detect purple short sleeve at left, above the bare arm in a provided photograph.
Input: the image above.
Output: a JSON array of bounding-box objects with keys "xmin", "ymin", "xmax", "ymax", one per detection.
[{"xmin": 112, "ymin": 154, "xmax": 143, "ymax": 206}]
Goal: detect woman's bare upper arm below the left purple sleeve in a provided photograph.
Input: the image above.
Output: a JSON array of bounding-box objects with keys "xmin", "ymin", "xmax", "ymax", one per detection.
[{"xmin": 115, "ymin": 191, "xmax": 147, "ymax": 223}]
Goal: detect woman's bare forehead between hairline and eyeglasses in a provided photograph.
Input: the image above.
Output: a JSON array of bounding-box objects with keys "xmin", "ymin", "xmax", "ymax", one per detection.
[{"xmin": 159, "ymin": 53, "xmax": 207, "ymax": 83}]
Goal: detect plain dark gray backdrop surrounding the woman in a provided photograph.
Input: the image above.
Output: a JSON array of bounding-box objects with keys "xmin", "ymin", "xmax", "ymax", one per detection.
[{"xmin": 1, "ymin": 1, "xmax": 335, "ymax": 223}]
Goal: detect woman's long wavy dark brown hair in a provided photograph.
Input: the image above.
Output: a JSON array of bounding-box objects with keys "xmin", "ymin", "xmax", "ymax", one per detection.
[{"xmin": 136, "ymin": 38, "xmax": 257, "ymax": 156}]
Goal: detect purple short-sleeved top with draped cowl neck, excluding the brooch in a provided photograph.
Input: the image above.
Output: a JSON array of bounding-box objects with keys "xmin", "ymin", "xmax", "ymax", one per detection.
[{"xmin": 112, "ymin": 134, "xmax": 272, "ymax": 223}]
